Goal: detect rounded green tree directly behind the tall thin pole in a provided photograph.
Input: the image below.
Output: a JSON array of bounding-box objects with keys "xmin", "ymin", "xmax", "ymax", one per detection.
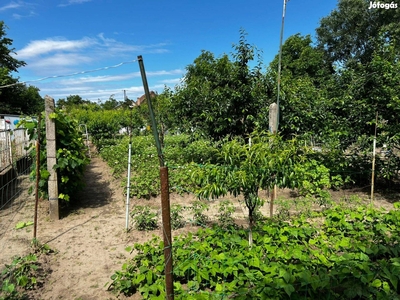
[{"xmin": 266, "ymin": 34, "xmax": 335, "ymax": 138}]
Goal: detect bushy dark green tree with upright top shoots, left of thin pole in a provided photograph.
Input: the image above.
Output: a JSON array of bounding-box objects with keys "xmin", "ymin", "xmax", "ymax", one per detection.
[{"xmin": 173, "ymin": 30, "xmax": 269, "ymax": 140}]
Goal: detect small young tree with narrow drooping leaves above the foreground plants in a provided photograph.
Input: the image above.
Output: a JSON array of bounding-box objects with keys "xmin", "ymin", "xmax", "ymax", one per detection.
[{"xmin": 193, "ymin": 134, "xmax": 307, "ymax": 245}]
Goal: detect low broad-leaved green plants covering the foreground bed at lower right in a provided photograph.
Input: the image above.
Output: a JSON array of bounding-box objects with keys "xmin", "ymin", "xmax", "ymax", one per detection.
[{"xmin": 110, "ymin": 205, "xmax": 400, "ymax": 300}]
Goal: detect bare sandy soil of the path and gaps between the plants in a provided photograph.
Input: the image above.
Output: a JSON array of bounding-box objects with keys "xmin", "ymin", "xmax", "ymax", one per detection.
[{"xmin": 0, "ymin": 149, "xmax": 399, "ymax": 300}]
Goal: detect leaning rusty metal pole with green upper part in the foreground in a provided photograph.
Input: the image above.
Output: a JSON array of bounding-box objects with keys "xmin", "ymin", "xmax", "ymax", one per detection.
[{"xmin": 138, "ymin": 55, "xmax": 174, "ymax": 300}]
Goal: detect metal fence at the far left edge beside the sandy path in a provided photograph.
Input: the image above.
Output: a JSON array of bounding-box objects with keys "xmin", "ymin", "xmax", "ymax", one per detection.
[{"xmin": 0, "ymin": 128, "xmax": 32, "ymax": 210}]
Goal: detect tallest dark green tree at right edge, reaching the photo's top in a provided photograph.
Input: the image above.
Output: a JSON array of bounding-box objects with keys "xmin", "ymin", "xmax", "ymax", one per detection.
[{"xmin": 317, "ymin": 0, "xmax": 400, "ymax": 182}]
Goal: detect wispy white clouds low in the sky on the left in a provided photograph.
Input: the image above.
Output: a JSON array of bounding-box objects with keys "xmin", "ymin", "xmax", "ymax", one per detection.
[{"xmin": 16, "ymin": 33, "xmax": 178, "ymax": 101}]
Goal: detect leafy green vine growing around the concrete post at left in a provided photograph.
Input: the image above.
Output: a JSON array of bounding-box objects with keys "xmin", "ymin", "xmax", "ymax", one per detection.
[{"xmin": 20, "ymin": 110, "xmax": 89, "ymax": 203}]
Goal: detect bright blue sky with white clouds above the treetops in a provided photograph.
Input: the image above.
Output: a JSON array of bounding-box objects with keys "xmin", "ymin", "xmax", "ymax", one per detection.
[{"xmin": 0, "ymin": 0, "xmax": 337, "ymax": 101}]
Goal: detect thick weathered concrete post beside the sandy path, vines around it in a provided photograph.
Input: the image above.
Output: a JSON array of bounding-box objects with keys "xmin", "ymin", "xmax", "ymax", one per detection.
[{"xmin": 44, "ymin": 95, "xmax": 60, "ymax": 220}]
